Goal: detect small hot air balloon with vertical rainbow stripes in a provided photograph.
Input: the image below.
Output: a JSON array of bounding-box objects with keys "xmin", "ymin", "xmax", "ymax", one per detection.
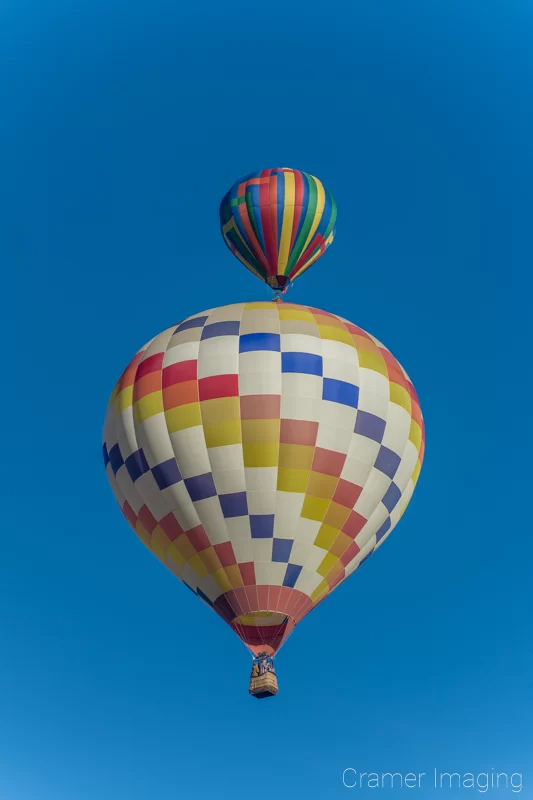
[{"xmin": 220, "ymin": 168, "xmax": 337, "ymax": 292}]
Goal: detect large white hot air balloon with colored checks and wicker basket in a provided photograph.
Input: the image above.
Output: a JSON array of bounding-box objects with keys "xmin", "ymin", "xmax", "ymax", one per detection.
[{"xmin": 103, "ymin": 302, "xmax": 424, "ymax": 697}]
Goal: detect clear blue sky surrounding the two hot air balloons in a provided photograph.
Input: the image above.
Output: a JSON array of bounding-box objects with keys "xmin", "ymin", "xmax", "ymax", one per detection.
[{"xmin": 0, "ymin": 0, "xmax": 533, "ymax": 800}]
